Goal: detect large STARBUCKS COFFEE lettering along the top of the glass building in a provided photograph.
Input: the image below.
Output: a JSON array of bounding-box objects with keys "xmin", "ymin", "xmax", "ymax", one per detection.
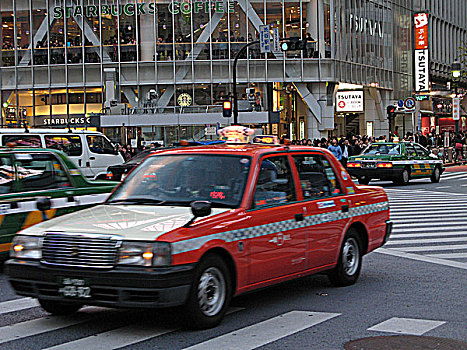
[{"xmin": 53, "ymin": 0, "xmax": 234, "ymax": 19}]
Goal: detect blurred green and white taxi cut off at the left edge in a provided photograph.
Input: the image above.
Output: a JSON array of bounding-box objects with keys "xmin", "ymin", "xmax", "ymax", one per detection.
[{"xmin": 0, "ymin": 147, "xmax": 117, "ymax": 260}]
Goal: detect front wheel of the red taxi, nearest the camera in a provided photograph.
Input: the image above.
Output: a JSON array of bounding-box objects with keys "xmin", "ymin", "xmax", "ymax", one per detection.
[{"xmin": 185, "ymin": 255, "xmax": 232, "ymax": 329}]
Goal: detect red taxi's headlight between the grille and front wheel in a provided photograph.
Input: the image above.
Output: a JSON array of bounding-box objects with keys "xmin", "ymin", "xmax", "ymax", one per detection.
[{"xmin": 118, "ymin": 242, "xmax": 172, "ymax": 267}]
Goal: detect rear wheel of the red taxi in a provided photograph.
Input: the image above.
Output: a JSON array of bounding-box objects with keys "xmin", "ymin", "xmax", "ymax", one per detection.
[{"xmin": 328, "ymin": 229, "xmax": 362, "ymax": 287}]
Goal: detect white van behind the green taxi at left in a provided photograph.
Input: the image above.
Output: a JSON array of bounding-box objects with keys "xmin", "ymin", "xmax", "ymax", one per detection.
[{"xmin": 0, "ymin": 128, "xmax": 124, "ymax": 179}]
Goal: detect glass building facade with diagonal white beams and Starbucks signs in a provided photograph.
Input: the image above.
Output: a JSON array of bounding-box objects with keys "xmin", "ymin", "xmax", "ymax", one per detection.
[{"xmin": 0, "ymin": 0, "xmax": 416, "ymax": 143}]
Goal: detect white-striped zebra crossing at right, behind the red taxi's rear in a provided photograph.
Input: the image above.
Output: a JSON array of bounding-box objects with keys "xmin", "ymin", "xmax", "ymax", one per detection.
[{"xmin": 384, "ymin": 188, "xmax": 467, "ymax": 268}]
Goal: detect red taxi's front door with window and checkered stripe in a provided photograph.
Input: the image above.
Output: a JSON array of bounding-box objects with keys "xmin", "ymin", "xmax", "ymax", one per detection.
[{"xmin": 247, "ymin": 155, "xmax": 306, "ymax": 283}]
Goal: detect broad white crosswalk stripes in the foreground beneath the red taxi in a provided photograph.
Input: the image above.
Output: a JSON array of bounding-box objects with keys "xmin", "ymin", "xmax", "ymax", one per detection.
[{"xmin": 0, "ymin": 298, "xmax": 456, "ymax": 350}]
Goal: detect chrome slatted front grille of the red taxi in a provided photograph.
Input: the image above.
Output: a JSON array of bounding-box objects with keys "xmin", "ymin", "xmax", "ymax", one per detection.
[{"xmin": 41, "ymin": 234, "xmax": 120, "ymax": 268}]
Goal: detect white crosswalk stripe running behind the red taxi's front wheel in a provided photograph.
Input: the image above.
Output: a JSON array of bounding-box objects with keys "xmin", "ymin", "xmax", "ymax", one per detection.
[{"xmin": 45, "ymin": 307, "xmax": 245, "ymax": 350}]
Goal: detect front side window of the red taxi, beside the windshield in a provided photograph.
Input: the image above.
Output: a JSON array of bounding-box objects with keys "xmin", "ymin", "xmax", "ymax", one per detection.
[{"xmin": 253, "ymin": 156, "xmax": 297, "ymax": 208}]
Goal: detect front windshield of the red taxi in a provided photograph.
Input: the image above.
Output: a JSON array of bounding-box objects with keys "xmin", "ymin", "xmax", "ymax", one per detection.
[{"xmin": 107, "ymin": 154, "xmax": 251, "ymax": 208}]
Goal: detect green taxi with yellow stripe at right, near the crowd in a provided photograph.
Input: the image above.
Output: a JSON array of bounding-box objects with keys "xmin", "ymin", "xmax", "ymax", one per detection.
[{"xmin": 347, "ymin": 142, "xmax": 444, "ymax": 185}]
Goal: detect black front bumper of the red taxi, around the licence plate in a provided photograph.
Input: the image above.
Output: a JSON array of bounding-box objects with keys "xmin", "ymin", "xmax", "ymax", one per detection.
[{"xmin": 5, "ymin": 259, "xmax": 195, "ymax": 308}]
